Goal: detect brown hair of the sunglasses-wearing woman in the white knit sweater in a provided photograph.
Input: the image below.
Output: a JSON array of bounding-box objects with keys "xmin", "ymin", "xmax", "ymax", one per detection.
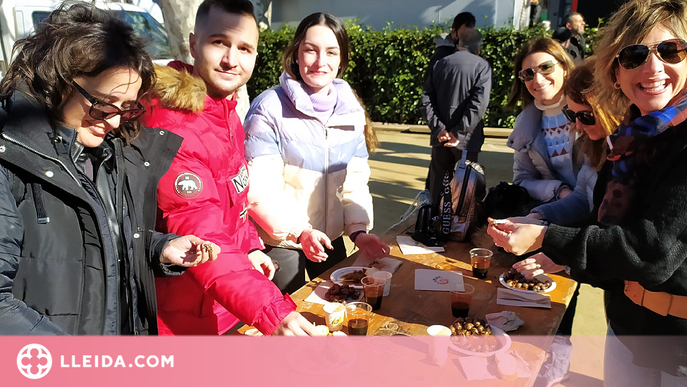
[{"xmin": 506, "ymin": 38, "xmax": 575, "ymax": 110}]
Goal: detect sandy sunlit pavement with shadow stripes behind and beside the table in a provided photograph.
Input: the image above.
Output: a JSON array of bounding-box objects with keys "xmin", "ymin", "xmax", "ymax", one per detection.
[{"xmin": 369, "ymin": 129, "xmax": 606, "ymax": 387}]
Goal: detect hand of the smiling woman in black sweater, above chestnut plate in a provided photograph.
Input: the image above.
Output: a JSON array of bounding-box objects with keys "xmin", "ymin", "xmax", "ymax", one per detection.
[{"xmin": 487, "ymin": 217, "xmax": 548, "ymax": 255}]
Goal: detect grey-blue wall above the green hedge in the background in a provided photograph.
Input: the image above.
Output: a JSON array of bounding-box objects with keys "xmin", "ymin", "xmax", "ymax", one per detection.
[{"xmin": 272, "ymin": 0, "xmax": 523, "ymax": 29}]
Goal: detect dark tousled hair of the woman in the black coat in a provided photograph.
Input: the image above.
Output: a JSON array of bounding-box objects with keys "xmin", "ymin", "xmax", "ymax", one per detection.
[{"xmin": 0, "ymin": 2, "xmax": 155, "ymax": 142}]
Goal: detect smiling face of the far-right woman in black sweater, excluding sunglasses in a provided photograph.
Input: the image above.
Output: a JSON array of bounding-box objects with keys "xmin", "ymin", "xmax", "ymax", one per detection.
[{"xmin": 615, "ymin": 25, "xmax": 687, "ymax": 115}]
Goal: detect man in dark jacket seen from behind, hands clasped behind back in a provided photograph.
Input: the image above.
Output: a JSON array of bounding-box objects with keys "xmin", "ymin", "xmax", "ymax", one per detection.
[{"xmin": 421, "ymin": 28, "xmax": 491, "ymax": 215}]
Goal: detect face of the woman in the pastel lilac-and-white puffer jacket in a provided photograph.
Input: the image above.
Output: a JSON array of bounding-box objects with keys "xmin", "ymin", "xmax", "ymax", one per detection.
[{"xmin": 298, "ymin": 25, "xmax": 341, "ymax": 93}]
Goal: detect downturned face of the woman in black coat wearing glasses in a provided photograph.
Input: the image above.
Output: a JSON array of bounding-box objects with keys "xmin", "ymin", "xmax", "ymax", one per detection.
[{"xmin": 61, "ymin": 67, "xmax": 142, "ymax": 148}]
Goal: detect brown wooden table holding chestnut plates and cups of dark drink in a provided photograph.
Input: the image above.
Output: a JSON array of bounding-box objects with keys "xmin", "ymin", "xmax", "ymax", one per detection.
[{"xmin": 241, "ymin": 223, "xmax": 577, "ymax": 386}]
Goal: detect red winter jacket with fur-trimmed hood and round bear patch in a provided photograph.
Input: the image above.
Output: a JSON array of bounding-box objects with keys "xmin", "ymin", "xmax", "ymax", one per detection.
[{"xmin": 145, "ymin": 62, "xmax": 296, "ymax": 335}]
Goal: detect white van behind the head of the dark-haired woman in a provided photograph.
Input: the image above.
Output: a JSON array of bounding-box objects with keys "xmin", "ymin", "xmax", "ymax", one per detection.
[{"xmin": 0, "ymin": 0, "xmax": 172, "ymax": 78}]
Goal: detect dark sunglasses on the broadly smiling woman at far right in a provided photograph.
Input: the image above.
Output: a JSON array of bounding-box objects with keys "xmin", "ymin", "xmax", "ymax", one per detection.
[{"xmin": 615, "ymin": 39, "xmax": 687, "ymax": 70}]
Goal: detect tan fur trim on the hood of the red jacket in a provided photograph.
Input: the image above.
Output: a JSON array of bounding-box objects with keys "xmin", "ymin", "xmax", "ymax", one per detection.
[{"xmin": 153, "ymin": 61, "xmax": 207, "ymax": 113}]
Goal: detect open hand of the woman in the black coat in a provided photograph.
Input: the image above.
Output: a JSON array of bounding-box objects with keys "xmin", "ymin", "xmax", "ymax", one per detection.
[{"xmin": 160, "ymin": 235, "xmax": 220, "ymax": 267}]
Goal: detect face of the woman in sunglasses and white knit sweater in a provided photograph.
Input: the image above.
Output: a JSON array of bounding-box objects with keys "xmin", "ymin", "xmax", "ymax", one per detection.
[{"xmin": 522, "ymin": 52, "xmax": 567, "ymax": 105}]
